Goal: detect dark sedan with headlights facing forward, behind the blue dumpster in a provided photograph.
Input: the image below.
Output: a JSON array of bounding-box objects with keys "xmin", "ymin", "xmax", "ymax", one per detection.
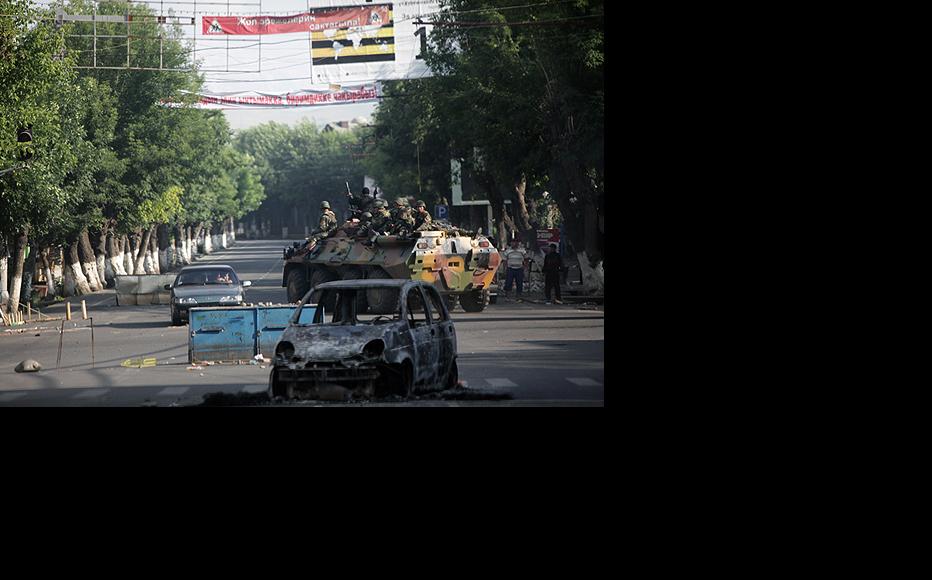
[{"xmin": 165, "ymin": 264, "xmax": 252, "ymax": 325}]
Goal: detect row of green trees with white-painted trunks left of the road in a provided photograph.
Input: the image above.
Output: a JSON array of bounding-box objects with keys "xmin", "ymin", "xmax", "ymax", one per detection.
[{"xmin": 0, "ymin": 0, "xmax": 264, "ymax": 318}]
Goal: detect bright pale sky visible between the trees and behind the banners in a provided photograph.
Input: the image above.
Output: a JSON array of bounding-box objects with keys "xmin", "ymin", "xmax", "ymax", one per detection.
[{"xmin": 36, "ymin": 0, "xmax": 437, "ymax": 129}]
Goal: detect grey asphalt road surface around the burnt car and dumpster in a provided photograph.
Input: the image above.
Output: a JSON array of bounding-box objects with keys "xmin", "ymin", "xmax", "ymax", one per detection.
[{"xmin": 0, "ymin": 240, "xmax": 605, "ymax": 406}]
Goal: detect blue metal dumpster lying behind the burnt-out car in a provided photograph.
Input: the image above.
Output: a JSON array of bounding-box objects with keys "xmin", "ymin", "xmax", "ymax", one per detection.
[{"xmin": 188, "ymin": 304, "xmax": 317, "ymax": 363}]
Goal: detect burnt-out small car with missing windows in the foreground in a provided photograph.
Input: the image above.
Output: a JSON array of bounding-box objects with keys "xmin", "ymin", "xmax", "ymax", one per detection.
[{"xmin": 269, "ymin": 279, "xmax": 459, "ymax": 399}]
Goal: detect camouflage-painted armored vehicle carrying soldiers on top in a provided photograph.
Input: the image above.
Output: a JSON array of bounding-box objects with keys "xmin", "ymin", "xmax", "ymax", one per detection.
[{"xmin": 282, "ymin": 221, "xmax": 501, "ymax": 314}]
